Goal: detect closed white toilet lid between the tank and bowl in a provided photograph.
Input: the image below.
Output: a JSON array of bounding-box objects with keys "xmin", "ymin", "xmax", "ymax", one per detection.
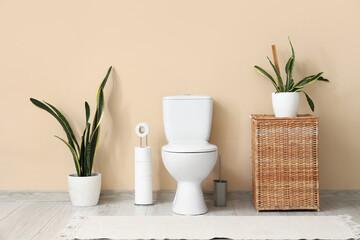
[{"xmin": 162, "ymin": 142, "xmax": 217, "ymax": 153}]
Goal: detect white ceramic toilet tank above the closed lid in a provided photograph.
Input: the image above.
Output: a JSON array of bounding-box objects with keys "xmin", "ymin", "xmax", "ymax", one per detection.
[{"xmin": 162, "ymin": 95, "xmax": 213, "ymax": 142}]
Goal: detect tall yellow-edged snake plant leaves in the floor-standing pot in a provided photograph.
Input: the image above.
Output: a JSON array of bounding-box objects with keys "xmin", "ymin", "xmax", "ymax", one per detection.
[{"xmin": 30, "ymin": 67, "xmax": 112, "ymax": 177}]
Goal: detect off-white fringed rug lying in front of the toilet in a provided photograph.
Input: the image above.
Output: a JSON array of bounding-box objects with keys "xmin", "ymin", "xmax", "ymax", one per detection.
[{"xmin": 60, "ymin": 215, "xmax": 360, "ymax": 240}]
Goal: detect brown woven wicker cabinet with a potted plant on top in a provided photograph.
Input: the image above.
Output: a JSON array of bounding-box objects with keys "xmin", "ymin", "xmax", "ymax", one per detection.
[{"xmin": 251, "ymin": 115, "xmax": 319, "ymax": 211}]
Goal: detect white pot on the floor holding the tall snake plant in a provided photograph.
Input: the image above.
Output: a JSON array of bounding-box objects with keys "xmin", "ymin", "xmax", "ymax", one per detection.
[{"xmin": 68, "ymin": 173, "xmax": 101, "ymax": 207}]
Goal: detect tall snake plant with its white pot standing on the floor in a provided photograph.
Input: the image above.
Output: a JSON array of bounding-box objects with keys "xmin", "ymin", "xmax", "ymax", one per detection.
[{"xmin": 30, "ymin": 67, "xmax": 112, "ymax": 207}]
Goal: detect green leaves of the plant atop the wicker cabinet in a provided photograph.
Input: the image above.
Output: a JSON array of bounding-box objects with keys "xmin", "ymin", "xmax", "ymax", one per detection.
[{"xmin": 254, "ymin": 38, "xmax": 329, "ymax": 111}]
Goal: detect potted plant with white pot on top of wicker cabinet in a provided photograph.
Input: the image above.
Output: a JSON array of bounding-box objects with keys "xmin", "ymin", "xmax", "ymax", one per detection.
[{"xmin": 254, "ymin": 38, "xmax": 329, "ymax": 117}]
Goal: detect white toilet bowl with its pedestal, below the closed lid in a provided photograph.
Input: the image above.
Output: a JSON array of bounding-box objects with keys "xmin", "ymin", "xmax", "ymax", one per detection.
[{"xmin": 162, "ymin": 146, "xmax": 217, "ymax": 215}]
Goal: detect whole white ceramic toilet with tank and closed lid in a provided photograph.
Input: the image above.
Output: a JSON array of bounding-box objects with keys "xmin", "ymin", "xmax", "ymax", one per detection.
[{"xmin": 161, "ymin": 95, "xmax": 217, "ymax": 215}]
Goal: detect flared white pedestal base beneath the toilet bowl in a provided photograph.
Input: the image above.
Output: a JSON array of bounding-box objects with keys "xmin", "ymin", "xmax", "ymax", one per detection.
[{"xmin": 172, "ymin": 182, "xmax": 208, "ymax": 215}]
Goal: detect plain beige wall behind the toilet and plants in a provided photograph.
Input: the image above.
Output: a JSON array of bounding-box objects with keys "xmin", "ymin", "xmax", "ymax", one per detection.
[{"xmin": 0, "ymin": 0, "xmax": 360, "ymax": 190}]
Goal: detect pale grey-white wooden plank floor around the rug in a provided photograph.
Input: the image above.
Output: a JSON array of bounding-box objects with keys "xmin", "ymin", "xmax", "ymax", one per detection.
[{"xmin": 0, "ymin": 190, "xmax": 360, "ymax": 240}]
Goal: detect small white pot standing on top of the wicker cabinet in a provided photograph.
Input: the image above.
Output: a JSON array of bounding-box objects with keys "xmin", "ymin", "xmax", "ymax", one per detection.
[{"xmin": 272, "ymin": 92, "xmax": 299, "ymax": 117}]
